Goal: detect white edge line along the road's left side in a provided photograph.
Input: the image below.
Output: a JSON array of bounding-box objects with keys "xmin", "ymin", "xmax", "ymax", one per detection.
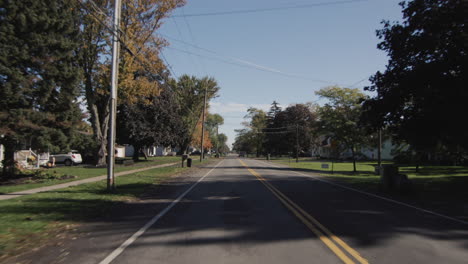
[{"xmin": 99, "ymin": 160, "xmax": 224, "ymax": 264}]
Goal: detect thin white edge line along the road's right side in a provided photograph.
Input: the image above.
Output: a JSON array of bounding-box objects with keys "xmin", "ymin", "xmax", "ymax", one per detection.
[{"xmin": 254, "ymin": 160, "xmax": 468, "ymax": 225}]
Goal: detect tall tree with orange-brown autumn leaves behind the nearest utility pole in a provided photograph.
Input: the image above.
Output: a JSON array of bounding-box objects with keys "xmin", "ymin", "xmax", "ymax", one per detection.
[{"xmin": 80, "ymin": 0, "xmax": 185, "ymax": 165}]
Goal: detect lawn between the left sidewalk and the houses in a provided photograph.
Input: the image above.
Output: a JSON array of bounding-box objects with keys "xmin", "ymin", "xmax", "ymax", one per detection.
[{"xmin": 0, "ymin": 157, "xmax": 181, "ymax": 194}]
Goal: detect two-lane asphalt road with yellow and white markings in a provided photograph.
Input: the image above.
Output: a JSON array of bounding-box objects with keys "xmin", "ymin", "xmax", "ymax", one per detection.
[{"xmin": 13, "ymin": 157, "xmax": 468, "ymax": 264}]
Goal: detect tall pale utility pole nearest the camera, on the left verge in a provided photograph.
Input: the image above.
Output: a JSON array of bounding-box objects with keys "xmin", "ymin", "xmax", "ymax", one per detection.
[{"xmin": 107, "ymin": 0, "xmax": 121, "ymax": 191}]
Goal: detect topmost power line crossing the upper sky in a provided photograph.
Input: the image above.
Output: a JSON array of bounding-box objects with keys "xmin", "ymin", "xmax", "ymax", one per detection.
[{"xmin": 172, "ymin": 0, "xmax": 367, "ymax": 17}]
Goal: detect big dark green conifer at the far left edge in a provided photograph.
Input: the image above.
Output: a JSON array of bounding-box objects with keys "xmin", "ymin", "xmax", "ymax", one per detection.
[{"xmin": 0, "ymin": 0, "xmax": 81, "ymax": 176}]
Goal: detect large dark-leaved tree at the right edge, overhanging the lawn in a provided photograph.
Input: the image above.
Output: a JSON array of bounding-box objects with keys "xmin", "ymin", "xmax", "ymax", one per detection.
[{"xmin": 363, "ymin": 0, "xmax": 468, "ymax": 156}]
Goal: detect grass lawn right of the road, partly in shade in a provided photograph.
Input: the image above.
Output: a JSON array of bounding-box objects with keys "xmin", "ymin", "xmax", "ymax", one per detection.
[{"xmin": 274, "ymin": 159, "xmax": 468, "ymax": 220}]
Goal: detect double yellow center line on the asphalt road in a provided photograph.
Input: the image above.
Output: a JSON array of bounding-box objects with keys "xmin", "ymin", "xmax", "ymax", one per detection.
[{"xmin": 239, "ymin": 160, "xmax": 369, "ymax": 264}]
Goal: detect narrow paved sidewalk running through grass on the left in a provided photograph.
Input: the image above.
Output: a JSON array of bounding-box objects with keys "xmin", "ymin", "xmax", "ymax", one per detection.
[{"xmin": 0, "ymin": 162, "xmax": 180, "ymax": 201}]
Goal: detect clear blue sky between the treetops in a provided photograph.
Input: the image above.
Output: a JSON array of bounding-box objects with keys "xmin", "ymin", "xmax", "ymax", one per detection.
[{"xmin": 159, "ymin": 0, "xmax": 401, "ymax": 144}]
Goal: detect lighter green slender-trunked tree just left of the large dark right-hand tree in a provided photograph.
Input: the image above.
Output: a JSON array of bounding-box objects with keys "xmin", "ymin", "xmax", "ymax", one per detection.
[{"xmin": 315, "ymin": 86, "xmax": 367, "ymax": 172}]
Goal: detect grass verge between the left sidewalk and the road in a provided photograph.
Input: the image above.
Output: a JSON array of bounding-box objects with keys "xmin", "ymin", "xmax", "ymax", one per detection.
[{"xmin": 0, "ymin": 160, "xmax": 210, "ymax": 262}]
